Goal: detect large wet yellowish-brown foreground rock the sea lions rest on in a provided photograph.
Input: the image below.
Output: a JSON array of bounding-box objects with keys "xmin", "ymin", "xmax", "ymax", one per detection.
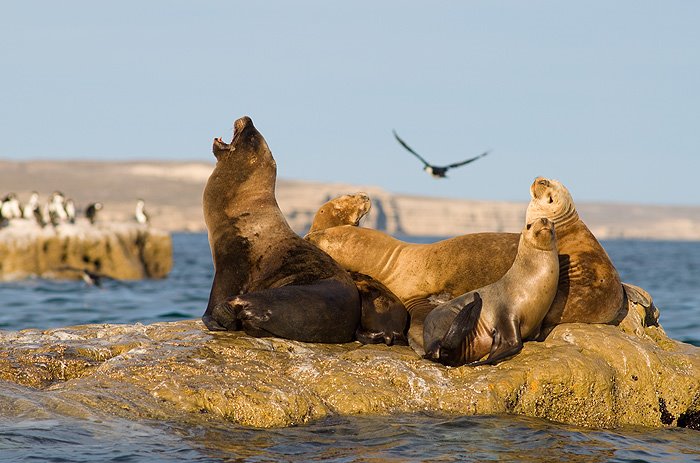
[{"xmin": 0, "ymin": 296, "xmax": 700, "ymax": 428}]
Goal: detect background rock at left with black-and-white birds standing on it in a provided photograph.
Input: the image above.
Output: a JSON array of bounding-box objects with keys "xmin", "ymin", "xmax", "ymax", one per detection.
[{"xmin": 0, "ymin": 219, "xmax": 173, "ymax": 280}]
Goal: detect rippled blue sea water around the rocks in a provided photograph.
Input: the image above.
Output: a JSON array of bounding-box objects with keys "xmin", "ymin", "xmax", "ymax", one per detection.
[{"xmin": 0, "ymin": 233, "xmax": 700, "ymax": 463}]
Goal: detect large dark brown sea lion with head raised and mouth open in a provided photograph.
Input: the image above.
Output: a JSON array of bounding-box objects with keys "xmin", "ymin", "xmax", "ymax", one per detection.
[{"xmin": 202, "ymin": 117, "xmax": 360, "ymax": 343}]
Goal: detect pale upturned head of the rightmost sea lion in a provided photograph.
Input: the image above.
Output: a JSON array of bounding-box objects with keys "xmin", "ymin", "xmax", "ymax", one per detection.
[{"xmin": 525, "ymin": 177, "xmax": 578, "ymax": 225}]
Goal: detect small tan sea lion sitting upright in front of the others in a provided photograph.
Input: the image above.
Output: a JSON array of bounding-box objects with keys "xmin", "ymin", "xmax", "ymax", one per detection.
[{"xmin": 423, "ymin": 218, "xmax": 559, "ymax": 366}]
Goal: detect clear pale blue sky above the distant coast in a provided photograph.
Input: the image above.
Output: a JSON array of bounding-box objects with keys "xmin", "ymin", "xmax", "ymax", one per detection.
[{"xmin": 0, "ymin": 0, "xmax": 700, "ymax": 205}]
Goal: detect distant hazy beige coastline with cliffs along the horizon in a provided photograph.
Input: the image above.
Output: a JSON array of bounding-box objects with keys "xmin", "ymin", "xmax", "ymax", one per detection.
[{"xmin": 0, "ymin": 161, "xmax": 700, "ymax": 240}]
